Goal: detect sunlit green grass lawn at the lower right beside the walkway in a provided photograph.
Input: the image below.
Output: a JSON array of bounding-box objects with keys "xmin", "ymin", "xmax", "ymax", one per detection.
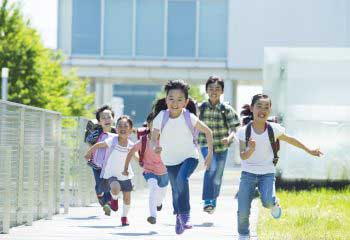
[{"xmin": 257, "ymin": 188, "xmax": 350, "ymax": 240}]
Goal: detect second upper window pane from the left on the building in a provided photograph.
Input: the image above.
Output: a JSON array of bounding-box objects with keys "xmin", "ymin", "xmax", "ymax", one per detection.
[{"xmin": 104, "ymin": 0, "xmax": 133, "ymax": 56}]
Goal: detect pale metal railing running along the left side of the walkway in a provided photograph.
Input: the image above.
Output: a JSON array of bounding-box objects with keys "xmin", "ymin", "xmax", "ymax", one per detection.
[{"xmin": 0, "ymin": 100, "xmax": 146, "ymax": 233}]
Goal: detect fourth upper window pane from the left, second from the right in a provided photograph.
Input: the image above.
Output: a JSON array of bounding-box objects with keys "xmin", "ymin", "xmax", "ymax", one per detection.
[{"xmin": 167, "ymin": 0, "xmax": 196, "ymax": 57}]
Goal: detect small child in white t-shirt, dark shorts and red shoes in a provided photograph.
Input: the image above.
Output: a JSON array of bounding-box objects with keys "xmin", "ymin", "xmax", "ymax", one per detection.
[{"xmin": 85, "ymin": 115, "xmax": 134, "ymax": 226}]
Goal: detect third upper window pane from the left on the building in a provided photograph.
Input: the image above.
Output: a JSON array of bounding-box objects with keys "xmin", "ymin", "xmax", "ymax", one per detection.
[{"xmin": 136, "ymin": 0, "xmax": 164, "ymax": 56}]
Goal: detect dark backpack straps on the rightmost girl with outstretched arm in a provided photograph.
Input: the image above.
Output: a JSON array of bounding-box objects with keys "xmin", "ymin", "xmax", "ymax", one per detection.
[{"xmin": 245, "ymin": 116, "xmax": 280, "ymax": 166}]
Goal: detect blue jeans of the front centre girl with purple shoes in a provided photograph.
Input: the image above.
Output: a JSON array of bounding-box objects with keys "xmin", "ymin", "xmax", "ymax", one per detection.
[{"xmin": 166, "ymin": 158, "xmax": 198, "ymax": 214}]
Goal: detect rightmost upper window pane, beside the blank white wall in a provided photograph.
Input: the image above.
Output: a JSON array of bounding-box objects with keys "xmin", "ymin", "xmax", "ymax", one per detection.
[{"xmin": 199, "ymin": 0, "xmax": 228, "ymax": 58}]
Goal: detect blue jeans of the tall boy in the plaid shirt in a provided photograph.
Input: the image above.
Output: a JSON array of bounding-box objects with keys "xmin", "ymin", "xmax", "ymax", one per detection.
[{"xmin": 201, "ymin": 147, "xmax": 227, "ymax": 200}]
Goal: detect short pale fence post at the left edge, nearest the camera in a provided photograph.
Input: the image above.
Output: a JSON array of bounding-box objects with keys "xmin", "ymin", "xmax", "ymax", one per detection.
[{"xmin": 0, "ymin": 146, "xmax": 12, "ymax": 233}]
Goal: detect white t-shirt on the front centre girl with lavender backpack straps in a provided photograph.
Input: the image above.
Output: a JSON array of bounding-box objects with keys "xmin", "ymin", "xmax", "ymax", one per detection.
[{"xmin": 153, "ymin": 111, "xmax": 199, "ymax": 166}]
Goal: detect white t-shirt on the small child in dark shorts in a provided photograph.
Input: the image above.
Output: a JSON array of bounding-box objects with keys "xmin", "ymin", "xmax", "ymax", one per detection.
[{"xmin": 103, "ymin": 137, "xmax": 134, "ymax": 181}]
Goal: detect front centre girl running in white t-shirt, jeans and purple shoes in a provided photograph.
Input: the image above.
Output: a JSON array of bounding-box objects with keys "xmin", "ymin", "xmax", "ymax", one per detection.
[{"xmin": 151, "ymin": 80, "xmax": 213, "ymax": 234}]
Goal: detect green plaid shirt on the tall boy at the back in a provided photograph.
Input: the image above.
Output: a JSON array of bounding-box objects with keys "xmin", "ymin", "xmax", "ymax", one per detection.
[{"xmin": 198, "ymin": 101, "xmax": 240, "ymax": 152}]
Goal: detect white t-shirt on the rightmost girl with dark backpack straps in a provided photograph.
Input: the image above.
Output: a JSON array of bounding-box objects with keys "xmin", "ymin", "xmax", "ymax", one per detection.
[{"xmin": 237, "ymin": 123, "xmax": 285, "ymax": 174}]
